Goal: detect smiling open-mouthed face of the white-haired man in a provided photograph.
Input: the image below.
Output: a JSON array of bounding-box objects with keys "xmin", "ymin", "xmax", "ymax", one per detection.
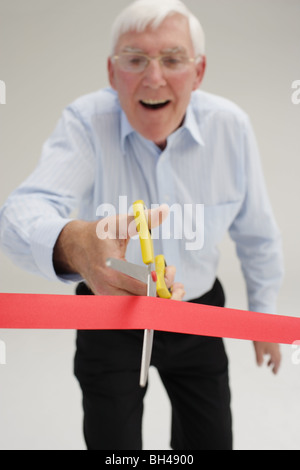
[{"xmin": 108, "ymin": 14, "xmax": 205, "ymax": 148}]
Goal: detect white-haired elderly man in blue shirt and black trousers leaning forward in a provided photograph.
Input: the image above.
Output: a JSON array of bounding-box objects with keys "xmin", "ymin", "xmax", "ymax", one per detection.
[{"xmin": 0, "ymin": 0, "xmax": 282, "ymax": 450}]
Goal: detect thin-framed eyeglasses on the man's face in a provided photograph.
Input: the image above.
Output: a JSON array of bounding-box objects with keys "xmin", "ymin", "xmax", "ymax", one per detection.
[{"xmin": 112, "ymin": 52, "xmax": 197, "ymax": 73}]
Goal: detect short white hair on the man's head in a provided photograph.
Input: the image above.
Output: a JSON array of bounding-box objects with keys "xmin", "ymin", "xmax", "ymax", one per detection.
[{"xmin": 111, "ymin": 0, "xmax": 205, "ymax": 57}]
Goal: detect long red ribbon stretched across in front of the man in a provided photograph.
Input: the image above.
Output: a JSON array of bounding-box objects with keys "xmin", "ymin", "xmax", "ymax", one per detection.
[{"xmin": 0, "ymin": 294, "xmax": 300, "ymax": 344}]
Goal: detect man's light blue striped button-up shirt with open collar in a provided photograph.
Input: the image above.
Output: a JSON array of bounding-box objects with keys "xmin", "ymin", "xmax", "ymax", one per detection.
[{"xmin": 0, "ymin": 88, "xmax": 283, "ymax": 313}]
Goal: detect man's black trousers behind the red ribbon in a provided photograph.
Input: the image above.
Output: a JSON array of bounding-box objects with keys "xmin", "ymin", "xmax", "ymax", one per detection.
[{"xmin": 75, "ymin": 280, "xmax": 232, "ymax": 450}]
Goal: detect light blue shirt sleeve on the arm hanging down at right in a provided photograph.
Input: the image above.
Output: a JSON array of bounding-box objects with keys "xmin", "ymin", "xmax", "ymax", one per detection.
[{"xmin": 229, "ymin": 120, "xmax": 284, "ymax": 313}]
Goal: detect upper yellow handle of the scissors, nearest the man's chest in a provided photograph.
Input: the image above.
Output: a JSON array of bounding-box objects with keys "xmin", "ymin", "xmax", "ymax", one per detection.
[{"xmin": 133, "ymin": 201, "xmax": 154, "ymax": 264}]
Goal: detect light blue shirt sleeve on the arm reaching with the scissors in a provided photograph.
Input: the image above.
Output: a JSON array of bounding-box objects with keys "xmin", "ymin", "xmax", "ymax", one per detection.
[{"xmin": 0, "ymin": 107, "xmax": 94, "ymax": 282}]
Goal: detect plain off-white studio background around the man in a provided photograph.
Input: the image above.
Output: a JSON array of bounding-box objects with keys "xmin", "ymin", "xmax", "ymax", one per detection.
[{"xmin": 0, "ymin": 0, "xmax": 300, "ymax": 450}]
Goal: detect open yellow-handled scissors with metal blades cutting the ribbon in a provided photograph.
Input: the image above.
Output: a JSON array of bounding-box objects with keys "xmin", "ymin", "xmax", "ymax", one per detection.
[{"xmin": 106, "ymin": 200, "xmax": 171, "ymax": 387}]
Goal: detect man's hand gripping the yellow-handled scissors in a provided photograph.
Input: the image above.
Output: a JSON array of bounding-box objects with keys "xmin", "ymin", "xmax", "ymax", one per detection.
[{"xmin": 53, "ymin": 205, "xmax": 184, "ymax": 300}]
